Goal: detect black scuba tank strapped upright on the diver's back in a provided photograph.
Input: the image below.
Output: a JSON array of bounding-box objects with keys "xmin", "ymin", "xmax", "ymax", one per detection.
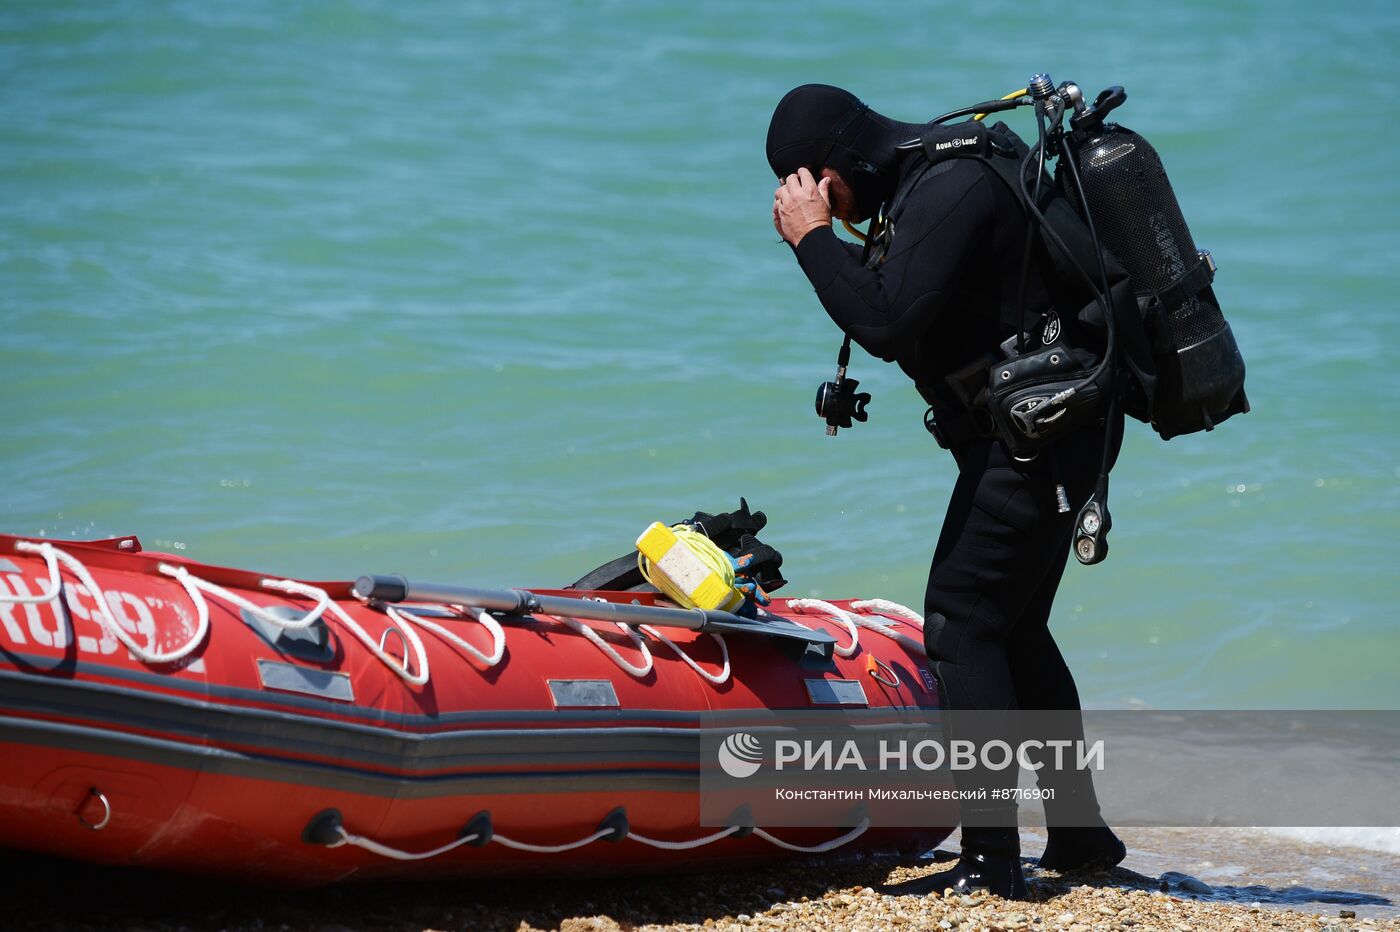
[{"xmin": 1056, "ymin": 87, "xmax": 1249, "ymax": 439}]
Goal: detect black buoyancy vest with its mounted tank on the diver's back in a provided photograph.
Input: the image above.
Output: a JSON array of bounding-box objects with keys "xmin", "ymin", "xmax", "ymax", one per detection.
[{"xmin": 918, "ymin": 98, "xmax": 1249, "ymax": 455}]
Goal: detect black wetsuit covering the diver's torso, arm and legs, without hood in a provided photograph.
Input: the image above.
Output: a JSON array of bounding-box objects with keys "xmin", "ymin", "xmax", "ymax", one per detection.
[{"xmin": 795, "ymin": 149, "xmax": 1117, "ymax": 824}]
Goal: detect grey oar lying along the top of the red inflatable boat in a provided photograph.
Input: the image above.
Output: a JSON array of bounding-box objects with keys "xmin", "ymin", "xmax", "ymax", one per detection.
[{"xmin": 354, "ymin": 575, "xmax": 836, "ymax": 659}]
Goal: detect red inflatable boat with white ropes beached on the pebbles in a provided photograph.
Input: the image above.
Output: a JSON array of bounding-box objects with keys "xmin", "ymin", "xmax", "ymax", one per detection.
[{"xmin": 0, "ymin": 536, "xmax": 953, "ymax": 884}]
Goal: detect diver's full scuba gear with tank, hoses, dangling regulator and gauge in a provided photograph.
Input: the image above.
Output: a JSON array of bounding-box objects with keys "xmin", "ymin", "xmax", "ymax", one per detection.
[{"xmin": 818, "ymin": 74, "xmax": 1249, "ymax": 564}]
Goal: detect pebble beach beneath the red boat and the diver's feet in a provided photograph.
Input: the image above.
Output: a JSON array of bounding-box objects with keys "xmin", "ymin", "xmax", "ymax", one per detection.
[{"xmin": 8, "ymin": 830, "xmax": 1400, "ymax": 932}]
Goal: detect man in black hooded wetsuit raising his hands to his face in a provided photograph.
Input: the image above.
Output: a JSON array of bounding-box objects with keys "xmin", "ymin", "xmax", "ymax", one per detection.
[{"xmin": 767, "ymin": 84, "xmax": 1126, "ymax": 898}]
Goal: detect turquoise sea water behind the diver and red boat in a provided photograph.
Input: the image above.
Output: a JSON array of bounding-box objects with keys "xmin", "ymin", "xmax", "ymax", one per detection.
[{"xmin": 0, "ymin": 0, "xmax": 1400, "ymax": 708}]
